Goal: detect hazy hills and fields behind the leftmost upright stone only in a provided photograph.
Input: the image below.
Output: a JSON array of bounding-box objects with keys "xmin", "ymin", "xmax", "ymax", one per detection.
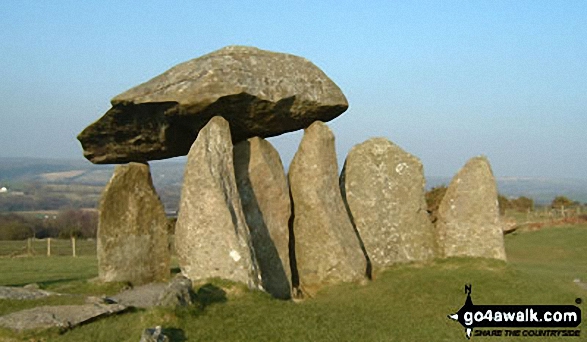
[{"xmin": 0, "ymin": 158, "xmax": 185, "ymax": 212}]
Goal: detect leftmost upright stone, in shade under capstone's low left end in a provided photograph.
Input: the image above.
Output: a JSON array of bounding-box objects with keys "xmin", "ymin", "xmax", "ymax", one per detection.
[{"xmin": 98, "ymin": 163, "xmax": 170, "ymax": 285}]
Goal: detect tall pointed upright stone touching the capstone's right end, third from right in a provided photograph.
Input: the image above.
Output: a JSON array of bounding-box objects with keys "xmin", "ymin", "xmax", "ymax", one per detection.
[{"xmin": 289, "ymin": 121, "xmax": 367, "ymax": 295}]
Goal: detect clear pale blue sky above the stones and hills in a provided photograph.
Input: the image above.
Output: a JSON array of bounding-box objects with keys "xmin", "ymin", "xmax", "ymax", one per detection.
[{"xmin": 0, "ymin": 0, "xmax": 587, "ymax": 179}]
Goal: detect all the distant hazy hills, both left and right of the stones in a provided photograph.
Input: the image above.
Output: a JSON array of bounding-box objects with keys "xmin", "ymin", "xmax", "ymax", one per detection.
[{"xmin": 0, "ymin": 158, "xmax": 587, "ymax": 211}]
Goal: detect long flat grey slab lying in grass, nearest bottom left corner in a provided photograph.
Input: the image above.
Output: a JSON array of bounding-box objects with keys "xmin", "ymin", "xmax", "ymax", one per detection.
[{"xmin": 0, "ymin": 304, "xmax": 126, "ymax": 331}]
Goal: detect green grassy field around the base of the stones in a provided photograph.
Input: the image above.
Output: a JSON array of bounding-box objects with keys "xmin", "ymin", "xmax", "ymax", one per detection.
[{"xmin": 0, "ymin": 225, "xmax": 587, "ymax": 341}]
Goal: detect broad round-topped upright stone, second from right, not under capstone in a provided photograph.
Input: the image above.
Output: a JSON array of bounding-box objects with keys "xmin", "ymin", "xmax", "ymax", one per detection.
[{"xmin": 340, "ymin": 138, "xmax": 435, "ymax": 270}]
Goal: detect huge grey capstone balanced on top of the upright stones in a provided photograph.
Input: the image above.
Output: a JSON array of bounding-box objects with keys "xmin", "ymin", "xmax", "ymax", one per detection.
[{"xmin": 78, "ymin": 46, "xmax": 348, "ymax": 164}]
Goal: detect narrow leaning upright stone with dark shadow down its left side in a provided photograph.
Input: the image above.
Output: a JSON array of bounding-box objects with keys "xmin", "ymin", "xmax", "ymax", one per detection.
[{"xmin": 234, "ymin": 137, "xmax": 291, "ymax": 299}]
